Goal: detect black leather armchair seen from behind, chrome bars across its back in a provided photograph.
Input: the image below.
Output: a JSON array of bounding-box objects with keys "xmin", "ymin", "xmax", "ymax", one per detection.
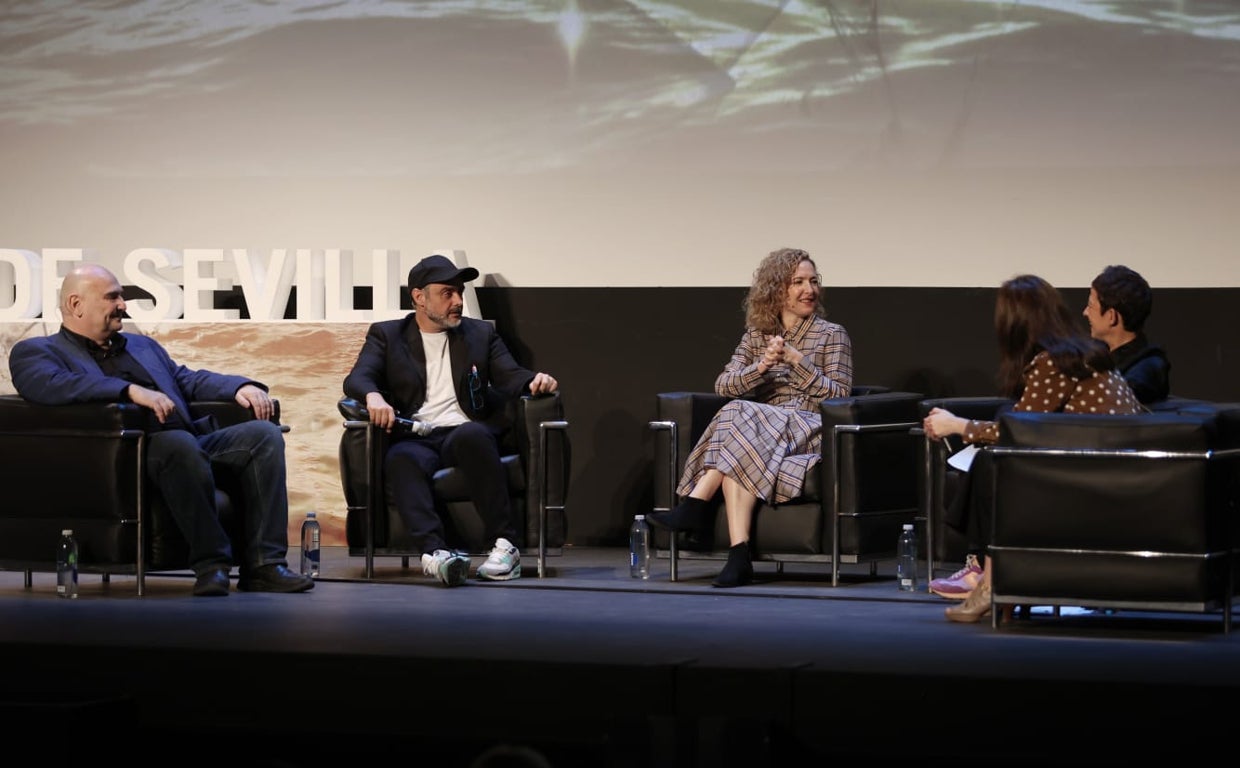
[{"xmin": 987, "ymin": 408, "xmax": 1240, "ymax": 632}]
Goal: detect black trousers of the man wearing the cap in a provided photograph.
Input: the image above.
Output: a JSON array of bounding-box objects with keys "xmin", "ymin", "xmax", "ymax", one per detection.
[{"xmin": 383, "ymin": 422, "xmax": 517, "ymax": 552}]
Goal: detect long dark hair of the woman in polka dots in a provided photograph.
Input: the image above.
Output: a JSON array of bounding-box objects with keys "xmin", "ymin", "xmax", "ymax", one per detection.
[{"xmin": 994, "ymin": 274, "xmax": 1115, "ymax": 397}]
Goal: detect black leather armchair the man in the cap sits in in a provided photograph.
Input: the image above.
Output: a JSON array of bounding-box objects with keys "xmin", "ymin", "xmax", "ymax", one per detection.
[{"xmin": 339, "ymin": 392, "xmax": 572, "ymax": 578}]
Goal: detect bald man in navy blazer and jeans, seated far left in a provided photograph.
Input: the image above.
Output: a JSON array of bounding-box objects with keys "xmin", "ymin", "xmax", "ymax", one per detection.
[{"xmin": 9, "ymin": 264, "xmax": 314, "ymax": 597}]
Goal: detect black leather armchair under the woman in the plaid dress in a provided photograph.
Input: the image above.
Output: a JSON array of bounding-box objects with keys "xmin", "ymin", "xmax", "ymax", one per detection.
[{"xmin": 650, "ymin": 386, "xmax": 923, "ymax": 586}]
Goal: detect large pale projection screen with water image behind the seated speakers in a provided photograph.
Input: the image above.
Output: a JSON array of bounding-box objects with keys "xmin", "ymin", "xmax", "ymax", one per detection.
[{"xmin": 0, "ymin": 0, "xmax": 1240, "ymax": 285}]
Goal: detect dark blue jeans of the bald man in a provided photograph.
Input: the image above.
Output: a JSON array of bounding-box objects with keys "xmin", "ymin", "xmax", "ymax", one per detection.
[{"xmin": 146, "ymin": 419, "xmax": 289, "ymax": 574}]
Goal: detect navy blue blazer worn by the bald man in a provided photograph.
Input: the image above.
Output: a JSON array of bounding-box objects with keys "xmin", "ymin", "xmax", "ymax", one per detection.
[{"xmin": 9, "ymin": 329, "xmax": 267, "ymax": 432}]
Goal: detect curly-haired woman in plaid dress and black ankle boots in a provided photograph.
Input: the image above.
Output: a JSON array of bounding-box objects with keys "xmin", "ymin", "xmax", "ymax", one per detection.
[{"xmin": 649, "ymin": 248, "xmax": 852, "ymax": 587}]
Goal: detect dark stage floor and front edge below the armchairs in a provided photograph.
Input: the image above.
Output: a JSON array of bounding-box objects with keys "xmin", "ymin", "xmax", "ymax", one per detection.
[{"xmin": 0, "ymin": 547, "xmax": 1240, "ymax": 768}]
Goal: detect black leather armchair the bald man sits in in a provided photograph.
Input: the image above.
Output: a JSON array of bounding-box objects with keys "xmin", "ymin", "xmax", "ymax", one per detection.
[{"xmin": 0, "ymin": 395, "xmax": 288, "ymax": 596}]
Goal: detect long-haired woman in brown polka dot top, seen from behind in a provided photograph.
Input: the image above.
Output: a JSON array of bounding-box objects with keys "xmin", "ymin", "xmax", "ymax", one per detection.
[{"xmin": 923, "ymin": 274, "xmax": 1145, "ymax": 622}]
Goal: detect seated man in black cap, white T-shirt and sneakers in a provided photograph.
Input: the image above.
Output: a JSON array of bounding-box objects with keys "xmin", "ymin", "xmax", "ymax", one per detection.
[{"xmin": 345, "ymin": 256, "xmax": 558, "ymax": 587}]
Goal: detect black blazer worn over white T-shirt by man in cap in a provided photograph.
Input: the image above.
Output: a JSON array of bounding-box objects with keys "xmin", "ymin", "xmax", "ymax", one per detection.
[{"xmin": 345, "ymin": 313, "xmax": 534, "ymax": 432}]
